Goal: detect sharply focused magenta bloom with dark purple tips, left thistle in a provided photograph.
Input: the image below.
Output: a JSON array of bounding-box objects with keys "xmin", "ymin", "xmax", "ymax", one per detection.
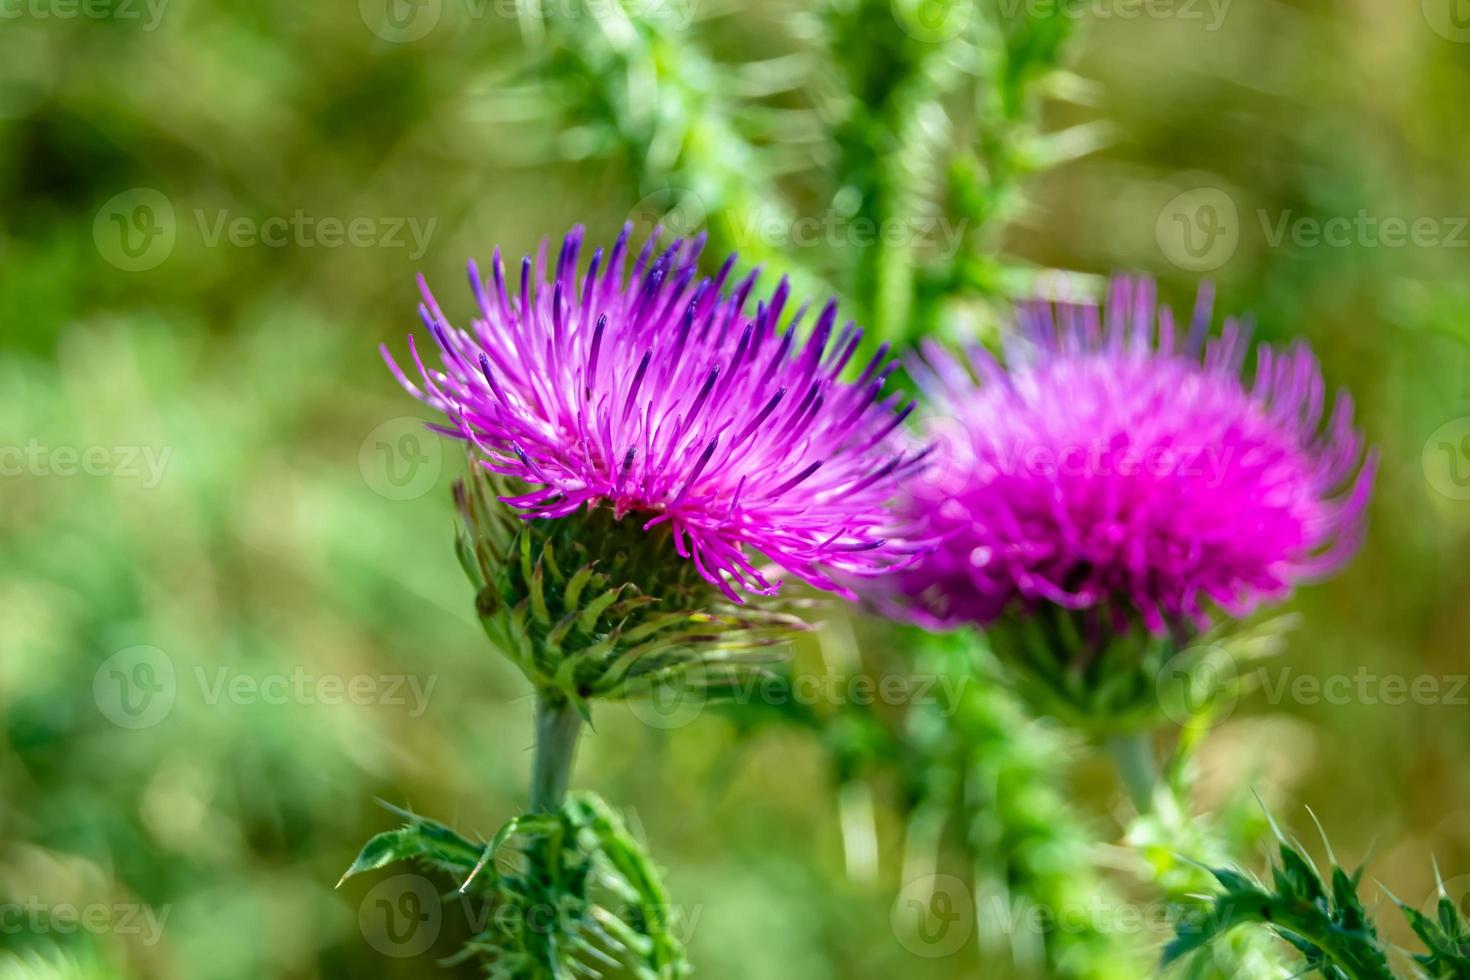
[{"xmin": 384, "ymin": 226, "xmax": 917, "ymax": 601}]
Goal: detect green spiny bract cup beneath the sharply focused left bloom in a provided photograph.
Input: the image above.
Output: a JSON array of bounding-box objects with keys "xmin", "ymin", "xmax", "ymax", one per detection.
[{"xmin": 454, "ymin": 466, "xmax": 806, "ymax": 717}]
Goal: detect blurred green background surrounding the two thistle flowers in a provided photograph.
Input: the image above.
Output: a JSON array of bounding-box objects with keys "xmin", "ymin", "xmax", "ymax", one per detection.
[{"xmin": 0, "ymin": 0, "xmax": 1470, "ymax": 980}]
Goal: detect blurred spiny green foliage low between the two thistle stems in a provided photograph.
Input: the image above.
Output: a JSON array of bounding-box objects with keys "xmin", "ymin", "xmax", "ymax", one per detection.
[{"xmin": 717, "ymin": 631, "xmax": 1147, "ymax": 980}]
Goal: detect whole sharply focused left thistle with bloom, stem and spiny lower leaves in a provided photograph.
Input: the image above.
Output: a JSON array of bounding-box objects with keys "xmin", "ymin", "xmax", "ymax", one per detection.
[{"xmin": 341, "ymin": 205, "xmax": 923, "ymax": 980}]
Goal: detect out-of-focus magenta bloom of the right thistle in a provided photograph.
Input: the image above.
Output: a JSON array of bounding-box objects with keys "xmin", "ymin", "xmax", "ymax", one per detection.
[{"xmin": 903, "ymin": 279, "xmax": 1374, "ymax": 635}]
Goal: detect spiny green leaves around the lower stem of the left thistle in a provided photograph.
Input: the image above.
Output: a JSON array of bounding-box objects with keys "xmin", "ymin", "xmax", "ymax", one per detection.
[{"xmin": 343, "ymin": 793, "xmax": 689, "ymax": 980}]
